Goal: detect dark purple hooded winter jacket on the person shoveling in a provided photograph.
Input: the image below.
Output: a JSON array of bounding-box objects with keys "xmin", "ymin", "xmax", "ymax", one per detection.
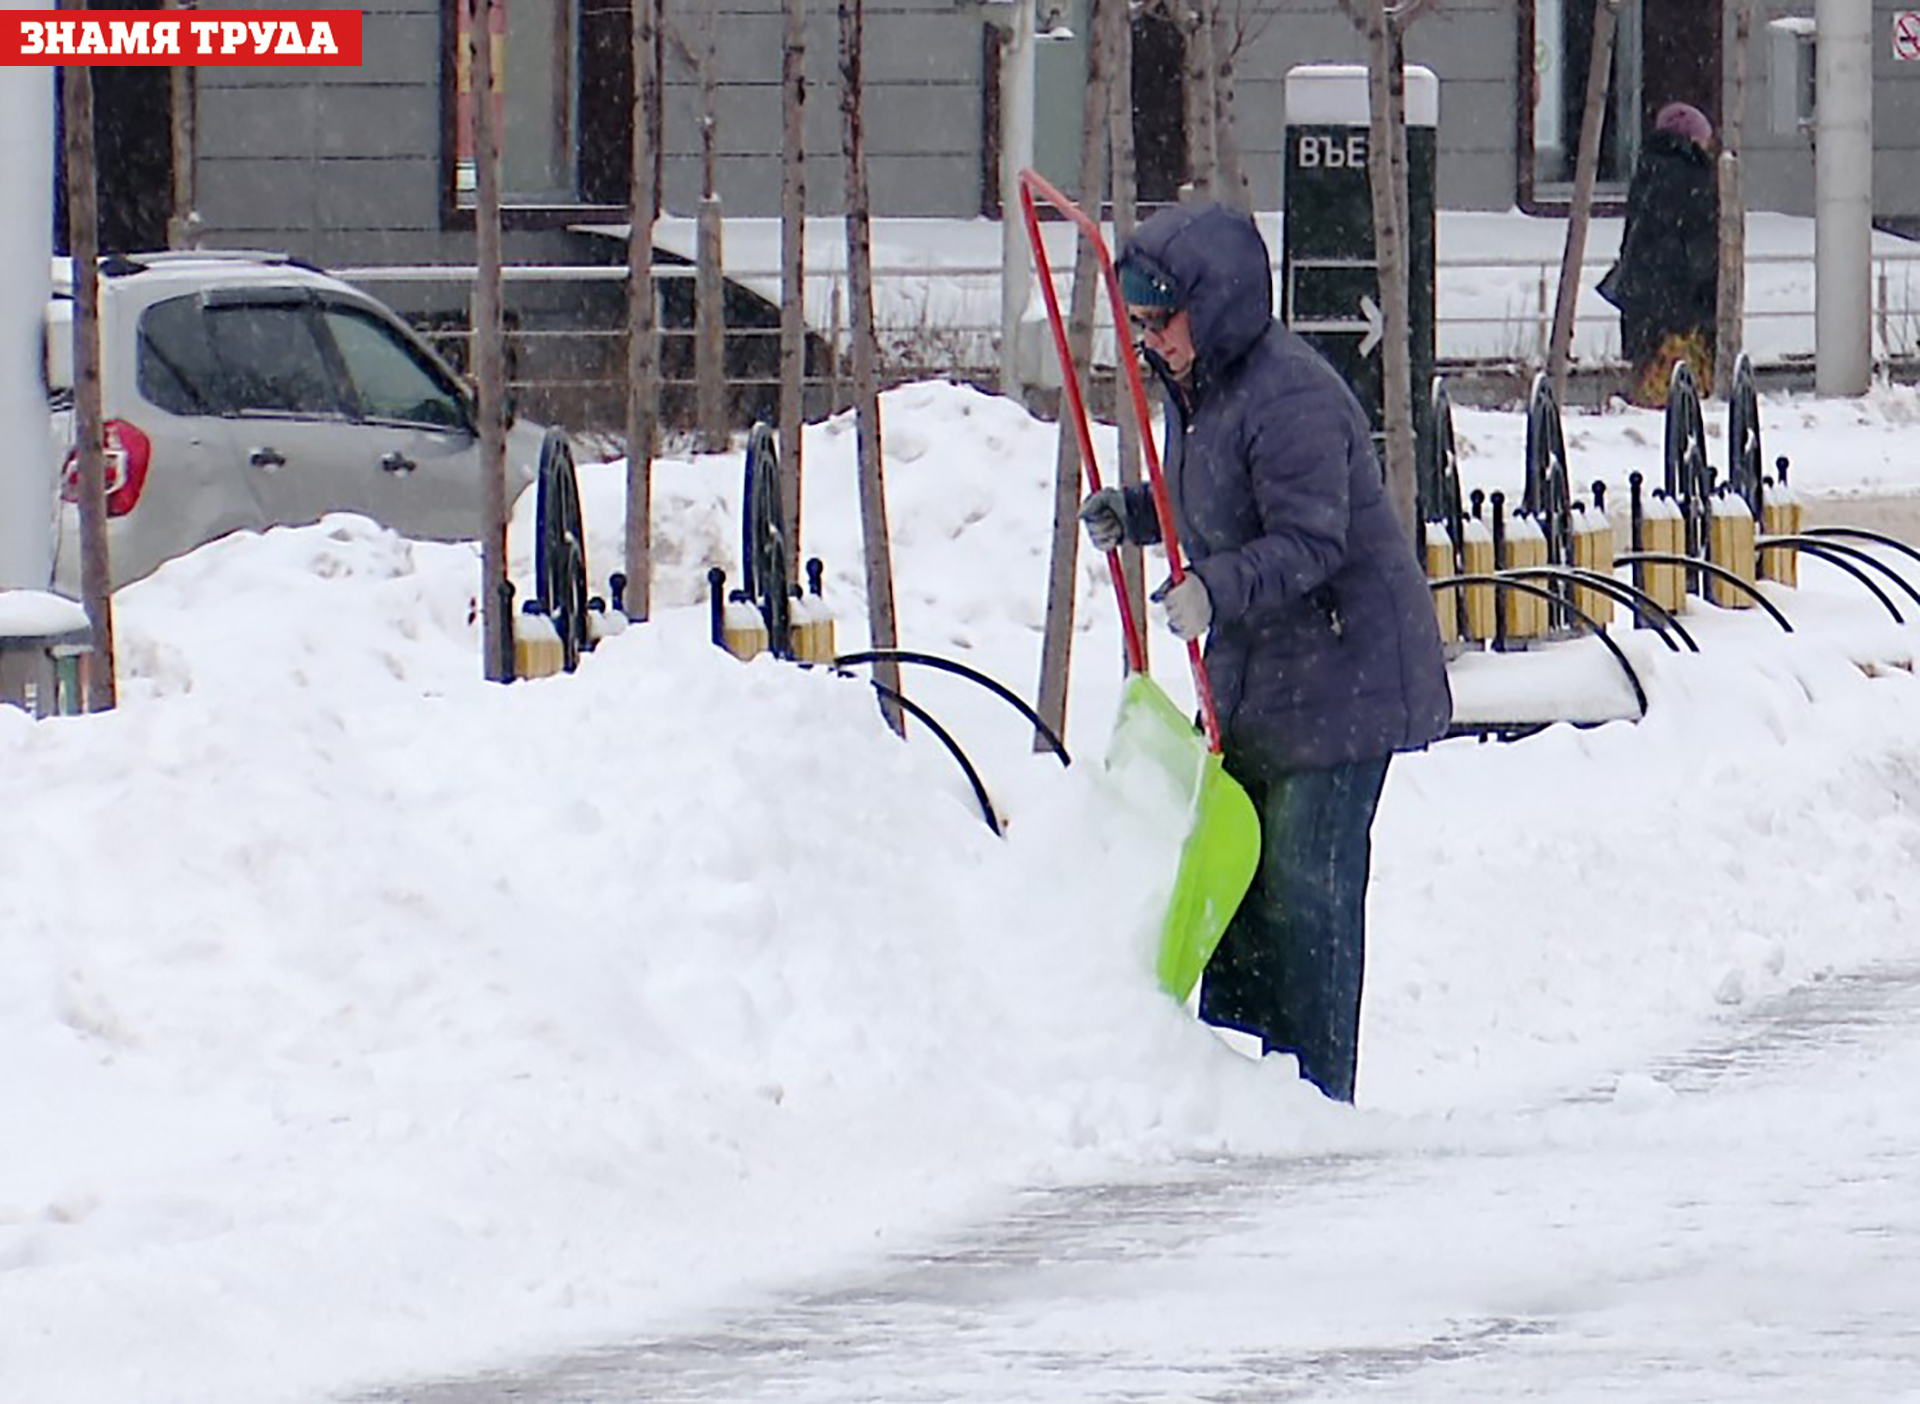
[{"xmin": 1119, "ymin": 204, "xmax": 1453, "ymax": 778}]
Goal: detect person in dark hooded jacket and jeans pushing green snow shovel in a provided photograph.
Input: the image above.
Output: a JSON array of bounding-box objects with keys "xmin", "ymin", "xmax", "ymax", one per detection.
[{"xmin": 1081, "ymin": 204, "xmax": 1452, "ymax": 1101}]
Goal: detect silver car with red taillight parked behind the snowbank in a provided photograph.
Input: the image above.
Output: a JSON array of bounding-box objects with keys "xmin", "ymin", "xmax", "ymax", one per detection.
[{"xmin": 48, "ymin": 252, "xmax": 541, "ymax": 595}]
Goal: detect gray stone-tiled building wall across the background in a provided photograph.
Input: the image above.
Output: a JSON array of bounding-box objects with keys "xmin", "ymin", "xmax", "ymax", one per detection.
[{"xmin": 183, "ymin": 0, "xmax": 1920, "ymax": 265}]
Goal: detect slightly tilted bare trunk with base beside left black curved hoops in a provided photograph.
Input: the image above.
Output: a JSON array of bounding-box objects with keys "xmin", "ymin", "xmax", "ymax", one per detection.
[{"xmin": 839, "ymin": 0, "xmax": 906, "ymax": 736}]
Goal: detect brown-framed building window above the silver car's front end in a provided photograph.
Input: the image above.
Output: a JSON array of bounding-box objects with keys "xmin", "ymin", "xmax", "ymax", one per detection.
[{"xmin": 444, "ymin": 0, "xmax": 632, "ymax": 211}]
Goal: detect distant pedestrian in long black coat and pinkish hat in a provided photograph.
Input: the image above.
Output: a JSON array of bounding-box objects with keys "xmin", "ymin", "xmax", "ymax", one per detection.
[{"xmin": 1599, "ymin": 102, "xmax": 1720, "ymax": 409}]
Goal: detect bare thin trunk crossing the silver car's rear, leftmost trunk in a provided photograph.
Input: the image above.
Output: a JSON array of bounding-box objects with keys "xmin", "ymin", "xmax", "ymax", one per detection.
[{"xmin": 60, "ymin": 56, "xmax": 117, "ymax": 713}]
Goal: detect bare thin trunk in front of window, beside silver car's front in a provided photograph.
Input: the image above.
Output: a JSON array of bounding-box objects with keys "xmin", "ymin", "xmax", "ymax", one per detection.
[{"xmin": 467, "ymin": 0, "xmax": 513, "ymax": 682}]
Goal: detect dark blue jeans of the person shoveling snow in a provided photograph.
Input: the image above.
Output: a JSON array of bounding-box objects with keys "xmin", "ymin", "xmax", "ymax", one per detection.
[{"xmin": 1200, "ymin": 757, "xmax": 1390, "ymax": 1102}]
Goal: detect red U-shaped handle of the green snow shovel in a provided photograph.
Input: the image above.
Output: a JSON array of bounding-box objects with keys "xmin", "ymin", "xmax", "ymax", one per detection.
[{"xmin": 1020, "ymin": 171, "xmax": 1219, "ymax": 753}]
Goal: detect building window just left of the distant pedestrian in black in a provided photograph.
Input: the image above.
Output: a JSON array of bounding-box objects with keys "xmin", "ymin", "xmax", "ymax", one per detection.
[{"xmin": 1521, "ymin": 0, "xmax": 1642, "ymax": 213}]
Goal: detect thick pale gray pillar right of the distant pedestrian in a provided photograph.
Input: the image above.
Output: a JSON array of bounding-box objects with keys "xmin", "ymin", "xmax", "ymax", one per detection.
[{"xmin": 1814, "ymin": 0, "xmax": 1874, "ymax": 396}]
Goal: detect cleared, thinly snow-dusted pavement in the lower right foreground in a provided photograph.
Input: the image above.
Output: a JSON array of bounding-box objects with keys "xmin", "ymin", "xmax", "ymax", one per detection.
[{"xmin": 378, "ymin": 962, "xmax": 1920, "ymax": 1404}]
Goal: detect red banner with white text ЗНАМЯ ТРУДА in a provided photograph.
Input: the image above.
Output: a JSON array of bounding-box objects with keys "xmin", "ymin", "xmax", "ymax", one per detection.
[{"xmin": 0, "ymin": 10, "xmax": 361, "ymax": 67}]
